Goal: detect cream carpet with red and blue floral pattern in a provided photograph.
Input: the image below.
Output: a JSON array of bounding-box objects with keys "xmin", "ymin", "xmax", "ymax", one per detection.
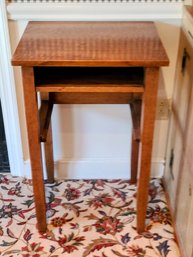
[{"xmin": 0, "ymin": 174, "xmax": 180, "ymax": 257}]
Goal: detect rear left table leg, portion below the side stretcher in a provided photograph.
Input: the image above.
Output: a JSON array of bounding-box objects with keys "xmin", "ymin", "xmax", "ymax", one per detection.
[{"xmin": 44, "ymin": 123, "xmax": 54, "ymax": 183}]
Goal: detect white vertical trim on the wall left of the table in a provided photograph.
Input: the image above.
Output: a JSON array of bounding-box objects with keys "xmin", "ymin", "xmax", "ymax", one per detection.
[{"xmin": 0, "ymin": 1, "xmax": 24, "ymax": 175}]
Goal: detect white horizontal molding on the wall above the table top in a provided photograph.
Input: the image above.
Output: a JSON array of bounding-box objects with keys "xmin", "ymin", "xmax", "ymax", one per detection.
[{"xmin": 7, "ymin": 1, "xmax": 183, "ymax": 23}]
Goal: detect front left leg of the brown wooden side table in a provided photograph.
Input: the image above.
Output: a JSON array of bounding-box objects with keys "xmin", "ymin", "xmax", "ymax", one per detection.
[{"xmin": 22, "ymin": 67, "xmax": 46, "ymax": 232}]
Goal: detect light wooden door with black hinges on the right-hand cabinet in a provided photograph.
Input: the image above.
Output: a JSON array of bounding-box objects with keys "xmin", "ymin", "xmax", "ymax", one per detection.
[{"xmin": 165, "ymin": 30, "xmax": 193, "ymax": 208}]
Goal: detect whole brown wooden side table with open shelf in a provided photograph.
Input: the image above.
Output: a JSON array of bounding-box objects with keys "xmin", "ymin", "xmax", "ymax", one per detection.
[{"xmin": 12, "ymin": 22, "xmax": 169, "ymax": 232}]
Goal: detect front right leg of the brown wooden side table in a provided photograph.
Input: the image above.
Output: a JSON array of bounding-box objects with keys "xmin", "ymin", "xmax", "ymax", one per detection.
[{"xmin": 137, "ymin": 68, "xmax": 159, "ymax": 233}]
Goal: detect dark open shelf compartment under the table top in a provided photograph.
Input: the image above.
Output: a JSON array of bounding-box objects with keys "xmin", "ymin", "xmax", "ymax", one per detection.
[{"xmin": 34, "ymin": 67, "xmax": 144, "ymax": 92}]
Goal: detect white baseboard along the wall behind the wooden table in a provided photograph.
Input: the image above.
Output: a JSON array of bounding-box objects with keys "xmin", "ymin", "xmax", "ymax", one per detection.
[{"xmin": 23, "ymin": 158, "xmax": 165, "ymax": 179}]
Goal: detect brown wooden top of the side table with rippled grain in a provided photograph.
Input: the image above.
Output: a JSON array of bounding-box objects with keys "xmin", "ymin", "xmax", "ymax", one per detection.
[{"xmin": 12, "ymin": 21, "xmax": 169, "ymax": 67}]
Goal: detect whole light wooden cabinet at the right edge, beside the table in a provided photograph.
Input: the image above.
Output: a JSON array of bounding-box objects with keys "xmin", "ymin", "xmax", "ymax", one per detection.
[{"xmin": 165, "ymin": 9, "xmax": 193, "ymax": 257}]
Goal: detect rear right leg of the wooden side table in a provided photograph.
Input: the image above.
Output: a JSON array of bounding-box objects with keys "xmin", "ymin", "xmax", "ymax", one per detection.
[{"xmin": 130, "ymin": 99, "xmax": 141, "ymax": 183}]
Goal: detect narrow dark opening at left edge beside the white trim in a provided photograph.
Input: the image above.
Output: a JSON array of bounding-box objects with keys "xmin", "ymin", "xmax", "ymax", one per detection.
[{"xmin": 0, "ymin": 102, "xmax": 10, "ymax": 173}]
